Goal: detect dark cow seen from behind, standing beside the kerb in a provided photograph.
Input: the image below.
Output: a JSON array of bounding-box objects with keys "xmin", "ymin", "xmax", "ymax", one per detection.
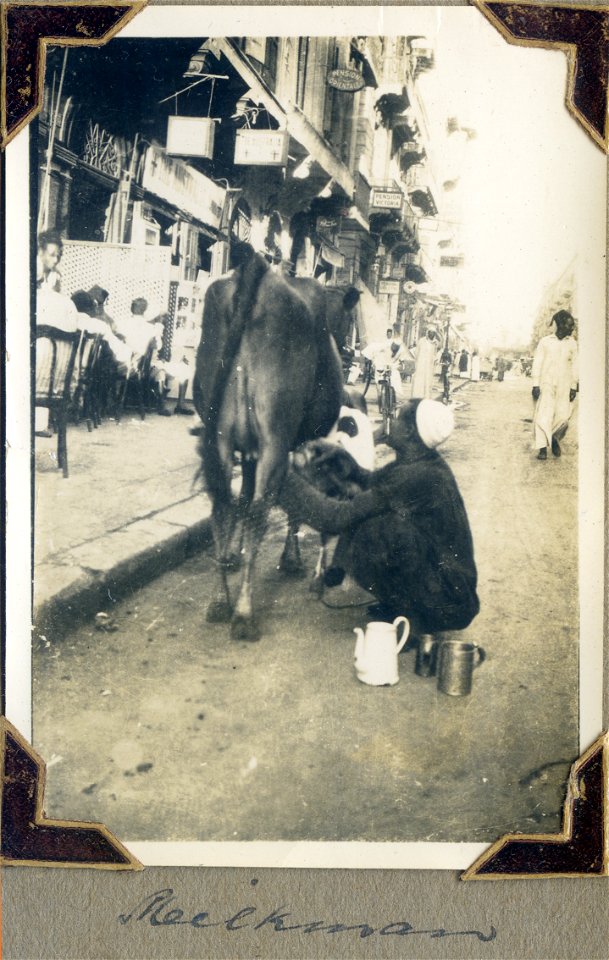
[{"xmin": 194, "ymin": 244, "xmax": 345, "ymax": 640}]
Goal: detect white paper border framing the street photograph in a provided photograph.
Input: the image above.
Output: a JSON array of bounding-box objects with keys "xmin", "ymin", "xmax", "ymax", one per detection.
[{"xmin": 5, "ymin": 4, "xmax": 606, "ymax": 870}]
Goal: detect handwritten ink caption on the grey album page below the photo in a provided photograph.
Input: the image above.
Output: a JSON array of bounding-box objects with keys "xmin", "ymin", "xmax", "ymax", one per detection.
[{"xmin": 118, "ymin": 879, "xmax": 497, "ymax": 943}]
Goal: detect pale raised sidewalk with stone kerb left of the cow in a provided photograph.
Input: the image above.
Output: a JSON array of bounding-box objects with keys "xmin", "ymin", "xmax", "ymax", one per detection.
[{"xmin": 34, "ymin": 381, "xmax": 469, "ymax": 635}]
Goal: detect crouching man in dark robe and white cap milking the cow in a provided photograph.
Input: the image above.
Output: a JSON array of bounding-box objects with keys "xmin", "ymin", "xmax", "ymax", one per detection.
[{"xmin": 279, "ymin": 399, "xmax": 480, "ymax": 634}]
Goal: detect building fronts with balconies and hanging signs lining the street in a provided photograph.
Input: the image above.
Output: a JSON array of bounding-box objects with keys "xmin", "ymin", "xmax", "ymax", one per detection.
[{"xmin": 37, "ymin": 36, "xmax": 452, "ymax": 356}]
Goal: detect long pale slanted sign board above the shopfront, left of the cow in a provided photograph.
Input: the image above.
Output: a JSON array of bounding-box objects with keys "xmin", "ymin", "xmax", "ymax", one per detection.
[{"xmin": 142, "ymin": 147, "xmax": 226, "ymax": 228}]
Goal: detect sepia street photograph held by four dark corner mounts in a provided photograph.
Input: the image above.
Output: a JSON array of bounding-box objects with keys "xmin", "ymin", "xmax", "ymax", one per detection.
[{"xmin": 10, "ymin": 6, "xmax": 605, "ymax": 866}]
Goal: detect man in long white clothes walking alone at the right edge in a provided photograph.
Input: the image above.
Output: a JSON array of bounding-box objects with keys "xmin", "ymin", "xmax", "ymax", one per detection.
[{"xmin": 531, "ymin": 310, "xmax": 578, "ymax": 460}]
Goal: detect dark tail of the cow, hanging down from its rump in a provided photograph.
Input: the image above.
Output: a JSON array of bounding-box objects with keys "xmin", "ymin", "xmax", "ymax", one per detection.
[{"xmin": 199, "ymin": 243, "xmax": 269, "ymax": 493}]
